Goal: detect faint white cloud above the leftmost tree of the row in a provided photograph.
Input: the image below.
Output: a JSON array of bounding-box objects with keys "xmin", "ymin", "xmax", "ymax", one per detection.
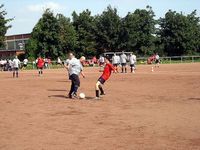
[{"xmin": 27, "ymin": 2, "xmax": 64, "ymax": 12}]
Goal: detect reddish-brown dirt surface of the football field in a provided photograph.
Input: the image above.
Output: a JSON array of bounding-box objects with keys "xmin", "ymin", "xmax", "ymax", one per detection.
[{"xmin": 0, "ymin": 63, "xmax": 200, "ymax": 150}]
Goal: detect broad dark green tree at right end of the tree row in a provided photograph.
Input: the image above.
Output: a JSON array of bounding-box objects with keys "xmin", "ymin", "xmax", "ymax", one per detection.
[{"xmin": 158, "ymin": 10, "xmax": 200, "ymax": 56}]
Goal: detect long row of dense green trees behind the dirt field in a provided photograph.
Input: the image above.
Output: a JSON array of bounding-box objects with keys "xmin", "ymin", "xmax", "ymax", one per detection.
[{"xmin": 0, "ymin": 6, "xmax": 200, "ymax": 59}]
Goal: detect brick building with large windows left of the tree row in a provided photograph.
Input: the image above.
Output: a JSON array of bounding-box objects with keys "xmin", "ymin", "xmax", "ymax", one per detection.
[{"xmin": 0, "ymin": 34, "xmax": 31, "ymax": 59}]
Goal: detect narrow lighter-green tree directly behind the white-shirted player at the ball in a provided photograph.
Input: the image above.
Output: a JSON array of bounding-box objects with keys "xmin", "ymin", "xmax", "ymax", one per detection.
[{"xmin": 57, "ymin": 14, "xmax": 78, "ymax": 55}]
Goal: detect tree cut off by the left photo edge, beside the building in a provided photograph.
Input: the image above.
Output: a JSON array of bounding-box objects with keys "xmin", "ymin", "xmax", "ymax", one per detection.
[{"xmin": 0, "ymin": 4, "xmax": 12, "ymax": 47}]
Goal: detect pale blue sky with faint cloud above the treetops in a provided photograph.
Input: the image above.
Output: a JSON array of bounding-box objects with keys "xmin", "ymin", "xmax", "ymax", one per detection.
[{"xmin": 0, "ymin": 0, "xmax": 200, "ymax": 35}]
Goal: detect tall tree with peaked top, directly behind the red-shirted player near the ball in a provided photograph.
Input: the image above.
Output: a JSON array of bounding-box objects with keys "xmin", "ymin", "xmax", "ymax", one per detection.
[{"xmin": 95, "ymin": 6, "xmax": 121, "ymax": 53}]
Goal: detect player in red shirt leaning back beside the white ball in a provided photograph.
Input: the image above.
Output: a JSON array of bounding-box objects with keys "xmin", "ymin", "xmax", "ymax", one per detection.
[{"xmin": 95, "ymin": 58, "xmax": 116, "ymax": 99}]
